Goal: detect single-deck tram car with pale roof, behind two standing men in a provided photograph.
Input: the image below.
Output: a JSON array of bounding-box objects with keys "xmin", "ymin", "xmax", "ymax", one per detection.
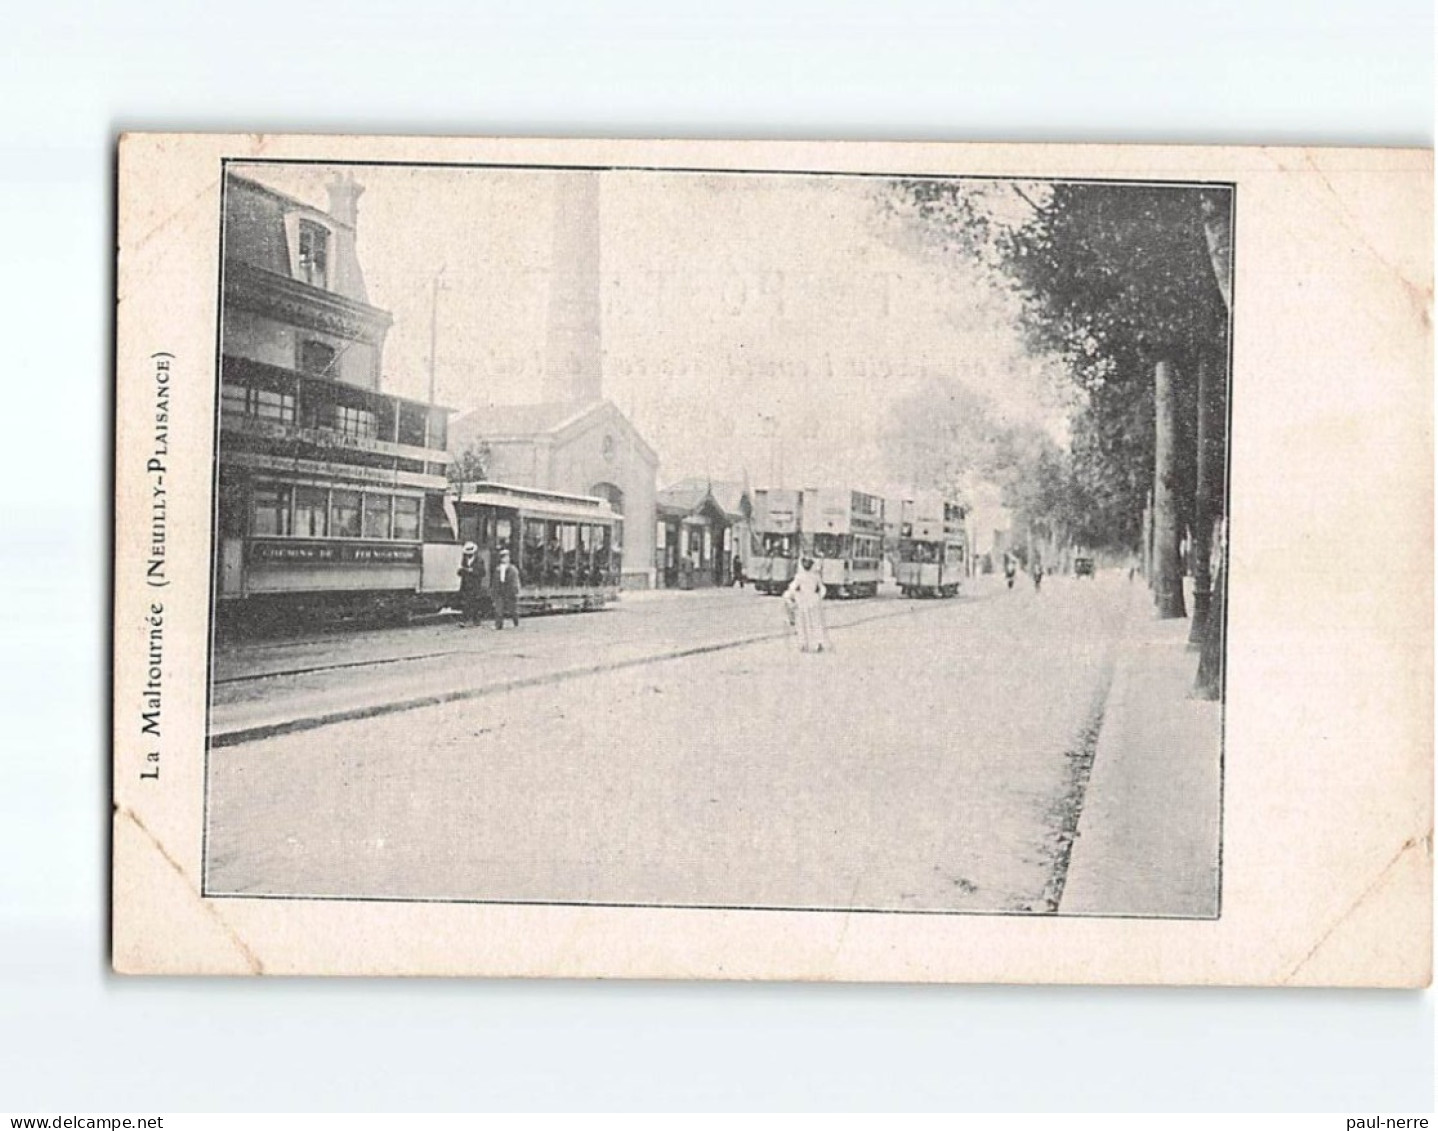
[{"xmin": 450, "ymin": 483, "xmax": 624, "ymax": 612}]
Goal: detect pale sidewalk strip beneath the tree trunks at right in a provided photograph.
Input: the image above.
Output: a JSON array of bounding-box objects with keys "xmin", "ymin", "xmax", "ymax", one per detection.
[{"xmin": 1058, "ymin": 581, "xmax": 1222, "ymax": 918}]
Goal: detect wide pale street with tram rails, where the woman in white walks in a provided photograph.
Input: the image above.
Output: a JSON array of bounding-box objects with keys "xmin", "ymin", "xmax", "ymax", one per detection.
[{"xmin": 207, "ymin": 575, "xmax": 1130, "ymax": 911}]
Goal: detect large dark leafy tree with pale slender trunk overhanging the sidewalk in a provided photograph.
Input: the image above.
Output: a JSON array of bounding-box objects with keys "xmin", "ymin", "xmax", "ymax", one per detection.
[{"xmin": 899, "ymin": 180, "xmax": 1227, "ymax": 615}]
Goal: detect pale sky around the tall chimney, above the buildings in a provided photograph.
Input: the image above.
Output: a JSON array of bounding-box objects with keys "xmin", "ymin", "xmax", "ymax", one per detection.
[{"xmin": 239, "ymin": 164, "xmax": 1066, "ymax": 490}]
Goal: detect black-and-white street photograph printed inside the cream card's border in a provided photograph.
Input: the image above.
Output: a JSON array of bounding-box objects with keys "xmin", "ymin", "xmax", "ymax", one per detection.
[{"xmin": 204, "ymin": 161, "xmax": 1241, "ymax": 918}]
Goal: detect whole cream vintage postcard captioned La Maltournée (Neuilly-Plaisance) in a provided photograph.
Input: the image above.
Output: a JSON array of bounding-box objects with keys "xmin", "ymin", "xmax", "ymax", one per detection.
[{"xmin": 114, "ymin": 135, "xmax": 1434, "ymax": 986}]
